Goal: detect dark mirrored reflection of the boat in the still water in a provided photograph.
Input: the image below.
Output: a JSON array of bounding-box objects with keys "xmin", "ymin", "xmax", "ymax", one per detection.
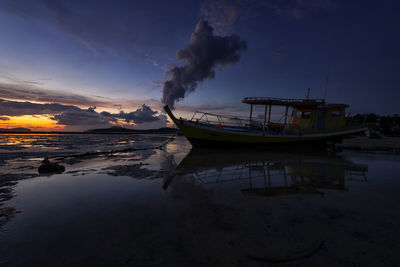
[{"xmin": 164, "ymin": 148, "xmax": 368, "ymax": 196}]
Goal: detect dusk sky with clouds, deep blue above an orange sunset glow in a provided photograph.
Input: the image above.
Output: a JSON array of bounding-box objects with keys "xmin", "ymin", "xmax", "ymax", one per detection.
[{"xmin": 0, "ymin": 0, "xmax": 400, "ymax": 131}]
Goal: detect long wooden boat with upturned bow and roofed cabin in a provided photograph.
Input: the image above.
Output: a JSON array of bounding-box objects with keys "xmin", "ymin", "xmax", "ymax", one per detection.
[{"xmin": 164, "ymin": 97, "xmax": 367, "ymax": 147}]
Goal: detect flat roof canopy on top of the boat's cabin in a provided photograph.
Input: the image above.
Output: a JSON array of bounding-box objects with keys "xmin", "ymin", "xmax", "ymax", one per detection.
[{"xmin": 242, "ymin": 97, "xmax": 349, "ymax": 109}]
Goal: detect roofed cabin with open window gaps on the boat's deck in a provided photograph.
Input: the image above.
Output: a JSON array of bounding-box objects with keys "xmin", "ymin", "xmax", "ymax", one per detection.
[{"xmin": 242, "ymin": 97, "xmax": 349, "ymax": 134}]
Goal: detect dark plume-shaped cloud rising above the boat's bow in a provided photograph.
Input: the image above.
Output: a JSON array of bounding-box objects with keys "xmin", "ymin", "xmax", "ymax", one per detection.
[{"xmin": 162, "ymin": 20, "xmax": 247, "ymax": 108}]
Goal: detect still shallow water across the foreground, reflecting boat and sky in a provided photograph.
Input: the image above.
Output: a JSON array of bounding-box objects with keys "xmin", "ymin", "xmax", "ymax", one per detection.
[{"xmin": 0, "ymin": 135, "xmax": 400, "ymax": 266}]
